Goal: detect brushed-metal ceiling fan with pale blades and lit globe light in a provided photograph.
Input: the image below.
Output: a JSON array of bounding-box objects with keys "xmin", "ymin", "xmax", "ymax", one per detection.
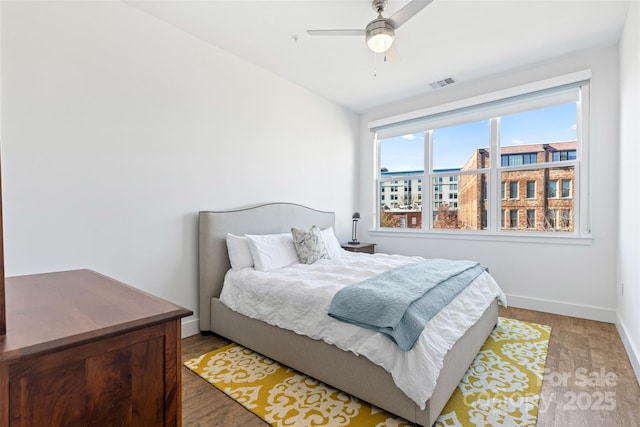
[{"xmin": 307, "ymin": 0, "xmax": 433, "ymax": 53}]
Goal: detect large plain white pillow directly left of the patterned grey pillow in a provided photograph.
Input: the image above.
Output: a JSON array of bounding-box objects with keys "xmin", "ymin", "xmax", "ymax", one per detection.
[{"xmin": 246, "ymin": 233, "xmax": 299, "ymax": 271}]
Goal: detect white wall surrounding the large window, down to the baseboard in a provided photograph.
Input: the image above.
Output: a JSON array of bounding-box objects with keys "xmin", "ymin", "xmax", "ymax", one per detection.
[{"xmin": 360, "ymin": 47, "xmax": 619, "ymax": 322}]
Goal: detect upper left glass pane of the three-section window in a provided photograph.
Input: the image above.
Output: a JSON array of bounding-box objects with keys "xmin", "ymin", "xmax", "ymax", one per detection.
[{"xmin": 380, "ymin": 132, "xmax": 425, "ymax": 173}]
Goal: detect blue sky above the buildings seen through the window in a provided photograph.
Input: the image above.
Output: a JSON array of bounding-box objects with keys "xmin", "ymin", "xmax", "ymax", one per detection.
[{"xmin": 380, "ymin": 103, "xmax": 576, "ymax": 172}]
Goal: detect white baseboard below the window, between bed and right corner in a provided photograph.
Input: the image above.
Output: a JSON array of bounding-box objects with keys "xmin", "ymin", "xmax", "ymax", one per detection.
[{"xmin": 507, "ymin": 295, "xmax": 617, "ymax": 323}]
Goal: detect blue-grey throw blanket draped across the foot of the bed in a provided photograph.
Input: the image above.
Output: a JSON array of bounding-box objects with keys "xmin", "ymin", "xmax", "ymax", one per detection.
[{"xmin": 329, "ymin": 259, "xmax": 487, "ymax": 351}]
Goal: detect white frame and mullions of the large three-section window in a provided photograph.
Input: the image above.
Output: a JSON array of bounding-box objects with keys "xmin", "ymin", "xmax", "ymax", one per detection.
[{"xmin": 369, "ymin": 70, "xmax": 591, "ymax": 244}]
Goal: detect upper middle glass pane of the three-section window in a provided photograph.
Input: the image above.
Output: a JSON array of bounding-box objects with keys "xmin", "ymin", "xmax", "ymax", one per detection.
[{"xmin": 433, "ymin": 120, "xmax": 490, "ymax": 172}]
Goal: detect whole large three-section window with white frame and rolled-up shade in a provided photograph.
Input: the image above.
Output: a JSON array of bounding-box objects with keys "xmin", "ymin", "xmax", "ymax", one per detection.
[{"xmin": 370, "ymin": 73, "xmax": 589, "ymax": 239}]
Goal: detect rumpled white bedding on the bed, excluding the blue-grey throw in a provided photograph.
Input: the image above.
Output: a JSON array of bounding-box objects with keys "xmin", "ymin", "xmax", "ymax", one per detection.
[{"xmin": 220, "ymin": 251, "xmax": 506, "ymax": 409}]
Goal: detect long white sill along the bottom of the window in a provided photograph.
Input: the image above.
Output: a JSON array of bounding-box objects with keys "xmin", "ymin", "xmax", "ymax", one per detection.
[{"xmin": 369, "ymin": 228, "xmax": 593, "ymax": 246}]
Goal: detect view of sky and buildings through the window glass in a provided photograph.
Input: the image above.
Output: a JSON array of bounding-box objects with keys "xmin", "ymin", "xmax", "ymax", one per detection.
[{"xmin": 379, "ymin": 102, "xmax": 578, "ymax": 232}]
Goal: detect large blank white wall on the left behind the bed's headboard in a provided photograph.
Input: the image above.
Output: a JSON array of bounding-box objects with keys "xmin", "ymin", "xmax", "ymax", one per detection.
[{"xmin": 1, "ymin": 1, "xmax": 358, "ymax": 333}]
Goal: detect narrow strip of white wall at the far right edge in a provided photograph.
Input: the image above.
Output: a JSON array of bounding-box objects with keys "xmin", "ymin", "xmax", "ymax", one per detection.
[{"xmin": 617, "ymin": 2, "xmax": 640, "ymax": 381}]
